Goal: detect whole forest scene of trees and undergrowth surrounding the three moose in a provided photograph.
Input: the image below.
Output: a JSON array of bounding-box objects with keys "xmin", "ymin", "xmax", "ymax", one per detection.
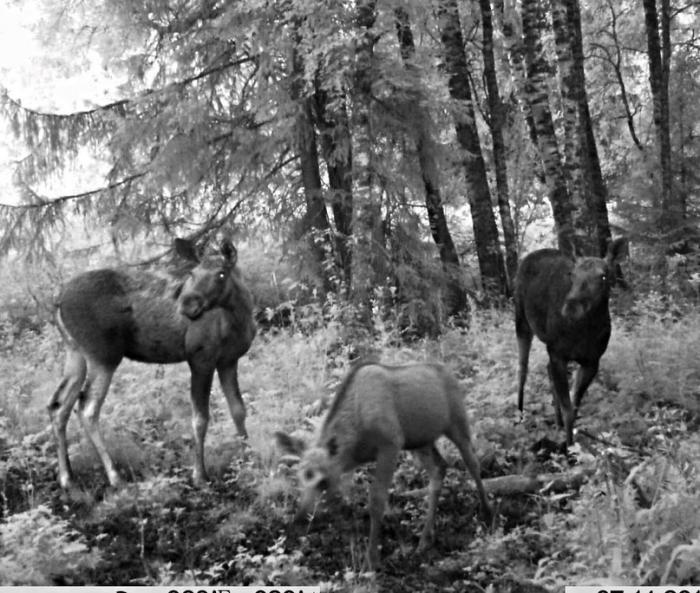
[{"xmin": 0, "ymin": 0, "xmax": 700, "ymax": 591}]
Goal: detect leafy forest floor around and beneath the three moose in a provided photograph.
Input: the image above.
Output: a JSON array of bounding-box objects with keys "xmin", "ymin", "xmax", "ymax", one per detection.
[{"xmin": 0, "ymin": 301, "xmax": 700, "ymax": 592}]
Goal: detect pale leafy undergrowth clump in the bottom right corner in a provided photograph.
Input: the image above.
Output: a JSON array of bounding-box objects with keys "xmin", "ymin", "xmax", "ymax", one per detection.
[{"xmin": 542, "ymin": 434, "xmax": 700, "ymax": 585}]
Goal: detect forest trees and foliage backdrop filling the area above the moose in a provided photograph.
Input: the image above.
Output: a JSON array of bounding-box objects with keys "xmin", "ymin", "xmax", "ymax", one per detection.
[{"xmin": 0, "ymin": 0, "xmax": 700, "ymax": 324}]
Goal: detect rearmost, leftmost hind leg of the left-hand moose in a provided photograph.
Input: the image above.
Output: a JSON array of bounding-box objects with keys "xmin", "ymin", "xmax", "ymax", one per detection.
[{"xmin": 48, "ymin": 348, "xmax": 87, "ymax": 488}]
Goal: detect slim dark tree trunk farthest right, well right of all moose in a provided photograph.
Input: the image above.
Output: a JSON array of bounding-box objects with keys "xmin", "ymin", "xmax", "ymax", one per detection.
[{"xmin": 644, "ymin": 0, "xmax": 685, "ymax": 232}]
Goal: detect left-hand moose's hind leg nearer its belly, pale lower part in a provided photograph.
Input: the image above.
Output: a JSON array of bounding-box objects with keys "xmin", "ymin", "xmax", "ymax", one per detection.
[{"xmin": 78, "ymin": 360, "xmax": 121, "ymax": 486}]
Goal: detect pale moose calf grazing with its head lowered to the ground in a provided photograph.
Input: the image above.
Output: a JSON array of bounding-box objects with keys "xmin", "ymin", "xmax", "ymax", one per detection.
[{"xmin": 276, "ymin": 363, "xmax": 492, "ymax": 567}]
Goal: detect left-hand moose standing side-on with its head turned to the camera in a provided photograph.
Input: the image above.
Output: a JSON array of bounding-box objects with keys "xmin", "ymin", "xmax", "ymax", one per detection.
[{"xmin": 48, "ymin": 239, "xmax": 255, "ymax": 488}]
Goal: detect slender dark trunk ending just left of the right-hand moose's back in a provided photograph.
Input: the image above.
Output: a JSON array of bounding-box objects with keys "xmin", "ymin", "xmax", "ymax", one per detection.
[{"xmin": 479, "ymin": 0, "xmax": 518, "ymax": 293}]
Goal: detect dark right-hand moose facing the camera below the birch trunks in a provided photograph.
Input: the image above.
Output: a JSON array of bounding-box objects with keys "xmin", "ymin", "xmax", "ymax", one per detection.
[{"xmin": 515, "ymin": 237, "xmax": 627, "ymax": 446}]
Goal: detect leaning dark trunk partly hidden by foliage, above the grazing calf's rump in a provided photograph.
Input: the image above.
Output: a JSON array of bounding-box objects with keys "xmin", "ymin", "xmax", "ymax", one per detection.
[{"xmin": 395, "ymin": 8, "xmax": 467, "ymax": 316}]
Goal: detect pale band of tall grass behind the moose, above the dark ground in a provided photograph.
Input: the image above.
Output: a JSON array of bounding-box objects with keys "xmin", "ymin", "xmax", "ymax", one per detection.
[{"xmin": 0, "ymin": 298, "xmax": 700, "ymax": 488}]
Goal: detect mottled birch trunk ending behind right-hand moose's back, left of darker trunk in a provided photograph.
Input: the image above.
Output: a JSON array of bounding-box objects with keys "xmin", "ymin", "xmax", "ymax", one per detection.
[{"xmin": 522, "ymin": 0, "xmax": 578, "ymax": 245}]
